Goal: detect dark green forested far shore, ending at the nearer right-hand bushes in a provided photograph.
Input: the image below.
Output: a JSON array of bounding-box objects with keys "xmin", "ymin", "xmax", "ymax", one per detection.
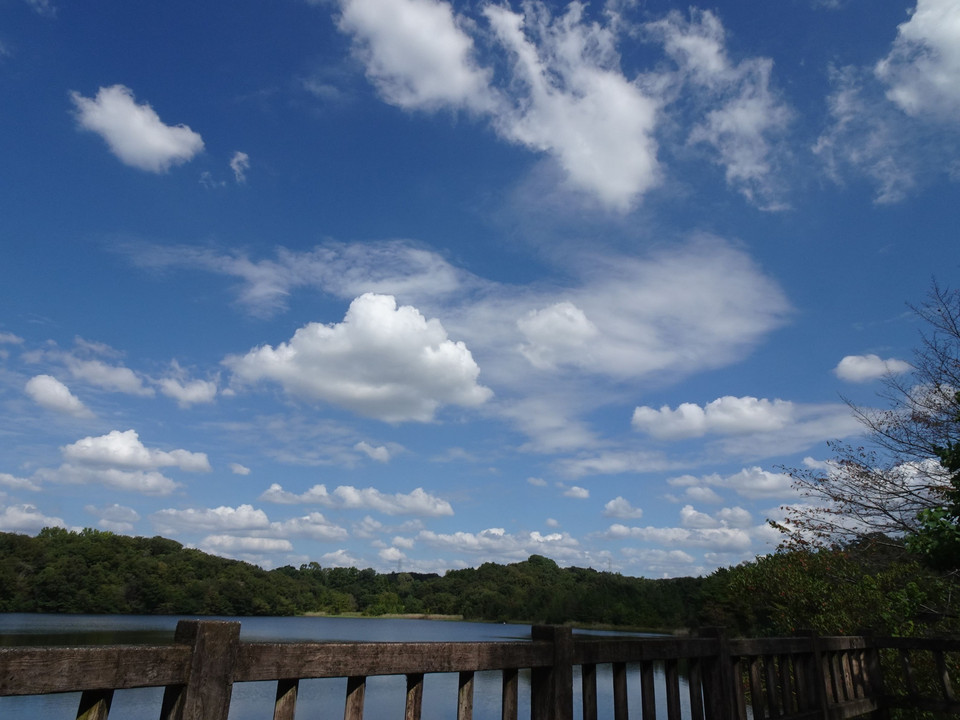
[{"xmin": 0, "ymin": 528, "xmax": 704, "ymax": 629}]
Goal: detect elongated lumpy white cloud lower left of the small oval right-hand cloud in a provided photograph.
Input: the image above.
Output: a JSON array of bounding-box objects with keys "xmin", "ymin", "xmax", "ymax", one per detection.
[{"xmin": 633, "ymin": 396, "xmax": 794, "ymax": 439}]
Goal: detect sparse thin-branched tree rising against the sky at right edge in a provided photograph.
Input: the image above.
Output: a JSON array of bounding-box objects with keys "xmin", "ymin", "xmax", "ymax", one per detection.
[{"xmin": 781, "ymin": 283, "xmax": 960, "ymax": 551}]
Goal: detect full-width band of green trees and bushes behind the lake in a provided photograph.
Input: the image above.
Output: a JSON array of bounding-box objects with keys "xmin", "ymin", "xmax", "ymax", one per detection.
[{"xmin": 0, "ymin": 528, "xmax": 960, "ymax": 635}]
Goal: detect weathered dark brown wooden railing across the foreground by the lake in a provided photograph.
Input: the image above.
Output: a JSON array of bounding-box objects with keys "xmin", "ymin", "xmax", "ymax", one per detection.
[{"xmin": 0, "ymin": 621, "xmax": 960, "ymax": 720}]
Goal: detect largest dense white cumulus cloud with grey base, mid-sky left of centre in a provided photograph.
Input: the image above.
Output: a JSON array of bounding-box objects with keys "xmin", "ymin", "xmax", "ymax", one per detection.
[{"xmin": 224, "ymin": 293, "xmax": 492, "ymax": 422}]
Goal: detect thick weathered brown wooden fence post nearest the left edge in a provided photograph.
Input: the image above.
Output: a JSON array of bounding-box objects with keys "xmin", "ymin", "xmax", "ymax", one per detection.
[{"xmin": 160, "ymin": 620, "xmax": 240, "ymax": 720}]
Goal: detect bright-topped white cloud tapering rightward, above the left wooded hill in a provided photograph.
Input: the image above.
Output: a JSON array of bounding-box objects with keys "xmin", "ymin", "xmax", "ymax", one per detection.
[{"xmin": 61, "ymin": 430, "xmax": 210, "ymax": 472}]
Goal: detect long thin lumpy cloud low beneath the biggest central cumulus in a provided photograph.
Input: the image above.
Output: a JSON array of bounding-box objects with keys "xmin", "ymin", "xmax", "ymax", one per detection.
[{"xmin": 260, "ymin": 483, "xmax": 453, "ymax": 517}]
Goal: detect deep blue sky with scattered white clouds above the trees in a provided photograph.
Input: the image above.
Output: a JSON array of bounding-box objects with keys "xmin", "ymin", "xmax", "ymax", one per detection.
[{"xmin": 0, "ymin": 0, "xmax": 960, "ymax": 577}]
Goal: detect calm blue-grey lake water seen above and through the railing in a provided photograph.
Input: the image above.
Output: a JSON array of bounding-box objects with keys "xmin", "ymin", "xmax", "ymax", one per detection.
[{"xmin": 0, "ymin": 614, "xmax": 686, "ymax": 720}]
